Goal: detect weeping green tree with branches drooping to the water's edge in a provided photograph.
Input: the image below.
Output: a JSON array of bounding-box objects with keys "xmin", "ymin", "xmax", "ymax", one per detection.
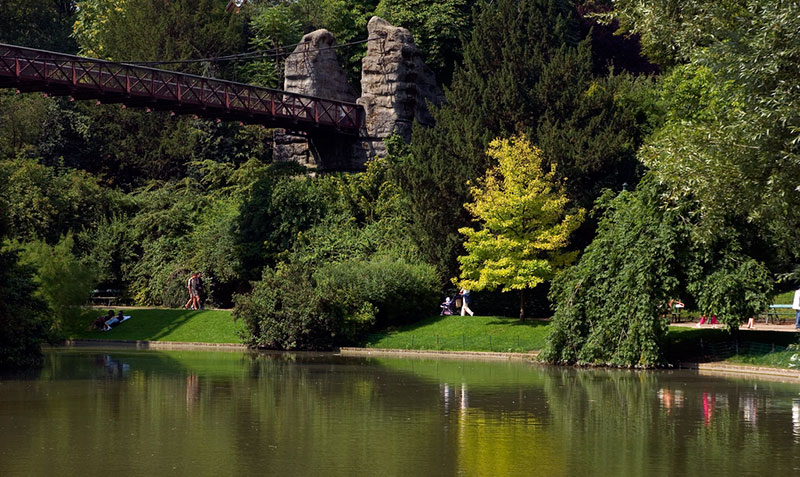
[{"xmin": 542, "ymin": 175, "xmax": 772, "ymax": 367}]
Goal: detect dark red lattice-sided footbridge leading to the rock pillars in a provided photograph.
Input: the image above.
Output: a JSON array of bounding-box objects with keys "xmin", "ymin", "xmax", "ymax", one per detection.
[{"xmin": 0, "ymin": 43, "xmax": 364, "ymax": 134}]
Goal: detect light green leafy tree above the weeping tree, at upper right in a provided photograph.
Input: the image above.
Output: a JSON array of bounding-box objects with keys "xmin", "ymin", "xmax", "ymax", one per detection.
[{"xmin": 615, "ymin": 0, "xmax": 800, "ymax": 266}]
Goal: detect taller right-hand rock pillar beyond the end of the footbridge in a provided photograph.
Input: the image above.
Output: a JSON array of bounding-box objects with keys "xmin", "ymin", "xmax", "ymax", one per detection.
[{"xmin": 358, "ymin": 17, "xmax": 444, "ymax": 157}]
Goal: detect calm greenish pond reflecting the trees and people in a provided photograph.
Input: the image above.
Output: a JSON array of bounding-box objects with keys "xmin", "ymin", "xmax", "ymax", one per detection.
[{"xmin": 0, "ymin": 350, "xmax": 800, "ymax": 476}]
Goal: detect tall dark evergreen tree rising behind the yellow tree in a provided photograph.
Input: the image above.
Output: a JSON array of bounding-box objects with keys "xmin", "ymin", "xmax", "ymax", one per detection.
[{"xmin": 397, "ymin": 0, "xmax": 642, "ymax": 277}]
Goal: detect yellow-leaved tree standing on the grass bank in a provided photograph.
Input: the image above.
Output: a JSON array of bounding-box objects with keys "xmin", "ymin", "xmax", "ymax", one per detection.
[{"xmin": 458, "ymin": 135, "xmax": 586, "ymax": 319}]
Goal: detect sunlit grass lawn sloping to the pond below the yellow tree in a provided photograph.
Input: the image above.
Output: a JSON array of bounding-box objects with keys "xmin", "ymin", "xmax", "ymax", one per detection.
[{"xmin": 363, "ymin": 316, "xmax": 550, "ymax": 352}]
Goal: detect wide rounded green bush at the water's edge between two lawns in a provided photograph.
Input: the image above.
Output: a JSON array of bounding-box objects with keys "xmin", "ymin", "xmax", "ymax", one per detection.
[{"xmin": 234, "ymin": 259, "xmax": 438, "ymax": 350}]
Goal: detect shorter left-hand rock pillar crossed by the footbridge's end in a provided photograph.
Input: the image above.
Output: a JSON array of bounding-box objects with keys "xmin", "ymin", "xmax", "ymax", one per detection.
[{"xmin": 273, "ymin": 30, "xmax": 356, "ymax": 169}]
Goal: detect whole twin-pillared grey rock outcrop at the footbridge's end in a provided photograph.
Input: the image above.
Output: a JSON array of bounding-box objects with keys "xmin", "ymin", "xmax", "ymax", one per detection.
[{"xmin": 274, "ymin": 17, "xmax": 444, "ymax": 170}]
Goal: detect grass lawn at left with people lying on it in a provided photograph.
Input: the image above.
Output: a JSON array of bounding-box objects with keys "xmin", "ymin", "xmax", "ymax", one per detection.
[{"xmin": 64, "ymin": 308, "xmax": 244, "ymax": 343}]
